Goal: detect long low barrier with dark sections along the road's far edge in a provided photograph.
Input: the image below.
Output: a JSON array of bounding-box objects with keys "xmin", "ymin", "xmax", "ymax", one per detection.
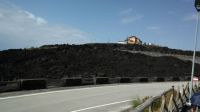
[{"xmin": 0, "ymin": 76, "xmax": 194, "ymax": 92}]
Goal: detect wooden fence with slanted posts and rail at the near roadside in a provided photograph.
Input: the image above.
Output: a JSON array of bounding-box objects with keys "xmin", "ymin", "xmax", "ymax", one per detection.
[{"xmin": 129, "ymin": 83, "xmax": 199, "ymax": 112}]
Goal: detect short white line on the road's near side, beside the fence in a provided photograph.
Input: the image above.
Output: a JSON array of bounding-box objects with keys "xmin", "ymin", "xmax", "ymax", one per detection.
[{"xmin": 71, "ymin": 100, "xmax": 132, "ymax": 112}]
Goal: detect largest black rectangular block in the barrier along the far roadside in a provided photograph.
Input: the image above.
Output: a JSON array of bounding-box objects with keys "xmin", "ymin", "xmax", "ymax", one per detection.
[{"xmin": 19, "ymin": 79, "xmax": 47, "ymax": 90}]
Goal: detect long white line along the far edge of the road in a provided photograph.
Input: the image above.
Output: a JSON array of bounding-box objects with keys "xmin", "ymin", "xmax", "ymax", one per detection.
[{"xmin": 0, "ymin": 84, "xmax": 134, "ymax": 100}]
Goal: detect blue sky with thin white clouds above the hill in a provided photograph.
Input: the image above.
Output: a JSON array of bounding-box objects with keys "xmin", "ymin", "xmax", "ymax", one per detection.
[{"xmin": 0, "ymin": 0, "xmax": 200, "ymax": 50}]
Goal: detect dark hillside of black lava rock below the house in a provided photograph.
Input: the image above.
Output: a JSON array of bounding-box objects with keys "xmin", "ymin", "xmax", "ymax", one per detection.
[{"xmin": 0, "ymin": 44, "xmax": 200, "ymax": 80}]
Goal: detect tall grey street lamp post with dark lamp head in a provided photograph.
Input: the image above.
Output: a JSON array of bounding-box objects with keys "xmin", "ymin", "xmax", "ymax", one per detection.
[{"xmin": 189, "ymin": 0, "xmax": 200, "ymax": 103}]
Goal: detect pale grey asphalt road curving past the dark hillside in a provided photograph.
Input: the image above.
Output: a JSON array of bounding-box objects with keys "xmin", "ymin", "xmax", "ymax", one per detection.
[{"xmin": 0, "ymin": 82, "xmax": 186, "ymax": 112}]
